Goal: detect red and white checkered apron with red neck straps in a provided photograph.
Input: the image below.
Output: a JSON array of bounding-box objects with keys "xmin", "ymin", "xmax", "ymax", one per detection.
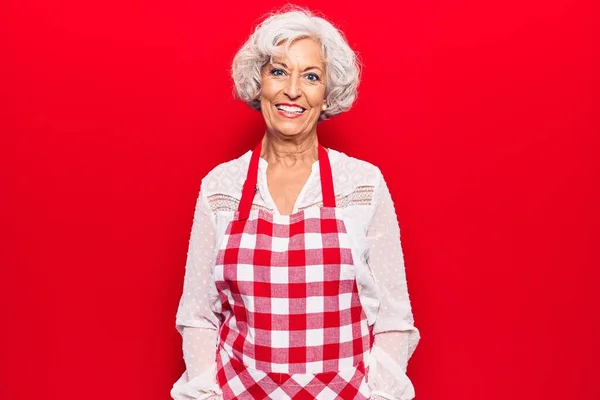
[{"xmin": 214, "ymin": 143, "xmax": 372, "ymax": 400}]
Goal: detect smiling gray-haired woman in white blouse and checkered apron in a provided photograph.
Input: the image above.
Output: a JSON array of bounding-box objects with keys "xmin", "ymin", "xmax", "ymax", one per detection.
[{"xmin": 171, "ymin": 8, "xmax": 420, "ymax": 400}]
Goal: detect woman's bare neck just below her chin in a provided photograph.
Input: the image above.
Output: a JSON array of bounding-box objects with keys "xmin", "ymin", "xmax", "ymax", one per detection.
[{"xmin": 261, "ymin": 130, "xmax": 319, "ymax": 167}]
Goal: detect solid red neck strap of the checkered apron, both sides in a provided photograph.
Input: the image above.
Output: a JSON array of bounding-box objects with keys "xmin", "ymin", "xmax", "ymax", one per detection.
[{"xmin": 238, "ymin": 140, "xmax": 335, "ymax": 220}]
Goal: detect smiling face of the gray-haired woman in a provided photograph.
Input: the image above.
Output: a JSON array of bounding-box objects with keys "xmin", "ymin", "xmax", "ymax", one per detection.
[{"xmin": 260, "ymin": 38, "xmax": 325, "ymax": 136}]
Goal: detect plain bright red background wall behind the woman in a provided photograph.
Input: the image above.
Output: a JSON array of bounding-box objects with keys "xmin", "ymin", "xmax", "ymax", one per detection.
[{"xmin": 0, "ymin": 0, "xmax": 600, "ymax": 400}]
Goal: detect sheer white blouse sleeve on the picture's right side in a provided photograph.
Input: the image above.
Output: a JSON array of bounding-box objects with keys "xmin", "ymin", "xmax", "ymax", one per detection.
[{"xmin": 367, "ymin": 176, "xmax": 420, "ymax": 400}]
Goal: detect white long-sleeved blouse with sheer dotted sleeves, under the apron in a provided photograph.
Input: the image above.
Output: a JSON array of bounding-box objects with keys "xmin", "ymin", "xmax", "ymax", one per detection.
[{"xmin": 171, "ymin": 149, "xmax": 420, "ymax": 400}]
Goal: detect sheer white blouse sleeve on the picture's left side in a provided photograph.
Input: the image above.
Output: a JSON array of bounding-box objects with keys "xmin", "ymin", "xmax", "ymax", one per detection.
[{"xmin": 171, "ymin": 185, "xmax": 221, "ymax": 400}]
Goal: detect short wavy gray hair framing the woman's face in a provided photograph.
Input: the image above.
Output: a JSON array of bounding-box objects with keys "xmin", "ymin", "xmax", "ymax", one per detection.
[{"xmin": 231, "ymin": 6, "xmax": 360, "ymax": 120}]
